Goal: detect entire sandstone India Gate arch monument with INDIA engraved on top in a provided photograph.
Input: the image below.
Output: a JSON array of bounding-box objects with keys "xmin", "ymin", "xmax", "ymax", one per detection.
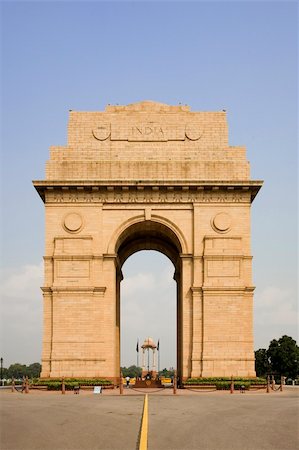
[{"xmin": 34, "ymin": 101, "xmax": 262, "ymax": 381}]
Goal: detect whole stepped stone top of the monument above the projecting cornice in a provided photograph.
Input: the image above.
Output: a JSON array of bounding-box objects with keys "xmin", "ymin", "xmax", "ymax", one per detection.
[{"xmin": 41, "ymin": 101, "xmax": 258, "ymax": 182}]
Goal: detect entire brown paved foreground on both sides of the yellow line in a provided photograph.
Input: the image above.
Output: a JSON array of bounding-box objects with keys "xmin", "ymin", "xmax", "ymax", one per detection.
[{"xmin": 0, "ymin": 388, "xmax": 299, "ymax": 450}]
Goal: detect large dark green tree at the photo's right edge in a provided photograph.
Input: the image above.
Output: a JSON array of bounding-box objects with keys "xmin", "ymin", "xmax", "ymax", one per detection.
[{"xmin": 267, "ymin": 335, "xmax": 299, "ymax": 379}]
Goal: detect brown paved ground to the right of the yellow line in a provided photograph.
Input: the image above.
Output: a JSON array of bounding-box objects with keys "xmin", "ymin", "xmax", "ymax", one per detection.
[{"xmin": 149, "ymin": 393, "xmax": 299, "ymax": 450}]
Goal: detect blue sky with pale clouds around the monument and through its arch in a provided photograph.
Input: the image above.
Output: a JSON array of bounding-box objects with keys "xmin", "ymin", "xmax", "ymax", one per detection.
[{"xmin": 1, "ymin": 1, "xmax": 298, "ymax": 366}]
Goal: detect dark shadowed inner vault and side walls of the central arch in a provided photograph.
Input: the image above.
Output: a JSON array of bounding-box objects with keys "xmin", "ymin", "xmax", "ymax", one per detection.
[{"xmin": 116, "ymin": 220, "xmax": 182, "ymax": 376}]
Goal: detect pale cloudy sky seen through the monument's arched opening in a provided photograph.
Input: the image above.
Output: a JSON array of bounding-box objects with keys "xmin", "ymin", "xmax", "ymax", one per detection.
[{"xmin": 120, "ymin": 250, "xmax": 177, "ymax": 371}]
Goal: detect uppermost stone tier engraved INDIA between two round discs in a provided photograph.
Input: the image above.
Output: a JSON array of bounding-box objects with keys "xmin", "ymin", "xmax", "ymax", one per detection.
[{"xmin": 68, "ymin": 101, "xmax": 228, "ymax": 145}]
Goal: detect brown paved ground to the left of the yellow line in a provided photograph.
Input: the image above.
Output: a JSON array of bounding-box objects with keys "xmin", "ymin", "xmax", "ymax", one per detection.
[{"xmin": 0, "ymin": 392, "xmax": 143, "ymax": 450}]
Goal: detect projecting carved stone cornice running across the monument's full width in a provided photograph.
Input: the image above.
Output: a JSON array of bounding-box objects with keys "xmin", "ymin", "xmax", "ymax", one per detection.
[{"xmin": 34, "ymin": 181, "xmax": 262, "ymax": 205}]
